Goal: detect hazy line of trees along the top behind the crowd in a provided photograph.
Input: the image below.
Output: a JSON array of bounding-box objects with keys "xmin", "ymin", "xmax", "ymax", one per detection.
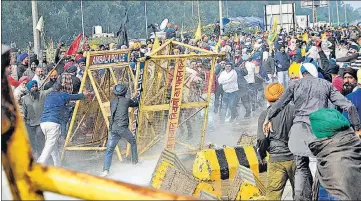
[{"xmin": 1, "ymin": 1, "xmax": 360, "ymax": 48}]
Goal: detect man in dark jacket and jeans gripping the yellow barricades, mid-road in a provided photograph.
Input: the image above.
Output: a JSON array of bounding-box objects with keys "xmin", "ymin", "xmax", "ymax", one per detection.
[{"xmin": 101, "ymin": 84, "xmax": 139, "ymax": 177}]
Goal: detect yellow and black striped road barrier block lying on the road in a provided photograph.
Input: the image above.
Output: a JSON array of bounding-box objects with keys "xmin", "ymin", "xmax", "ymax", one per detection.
[{"xmin": 193, "ymin": 146, "xmax": 267, "ymax": 181}]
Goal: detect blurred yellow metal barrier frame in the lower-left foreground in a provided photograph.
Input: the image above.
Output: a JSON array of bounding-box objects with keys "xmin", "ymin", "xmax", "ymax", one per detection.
[{"xmin": 1, "ymin": 53, "xmax": 192, "ymax": 200}]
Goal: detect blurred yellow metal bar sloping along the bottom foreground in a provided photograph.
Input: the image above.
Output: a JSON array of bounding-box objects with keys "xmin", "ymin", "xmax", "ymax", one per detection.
[{"xmin": 28, "ymin": 164, "xmax": 194, "ymax": 200}]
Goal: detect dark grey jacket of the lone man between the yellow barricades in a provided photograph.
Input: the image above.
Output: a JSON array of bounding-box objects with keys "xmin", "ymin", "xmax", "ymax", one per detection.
[{"xmin": 109, "ymin": 96, "xmax": 139, "ymax": 131}]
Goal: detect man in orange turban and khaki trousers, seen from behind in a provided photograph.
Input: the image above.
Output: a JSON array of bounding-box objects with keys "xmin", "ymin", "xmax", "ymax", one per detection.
[{"xmin": 257, "ymin": 83, "xmax": 296, "ymax": 200}]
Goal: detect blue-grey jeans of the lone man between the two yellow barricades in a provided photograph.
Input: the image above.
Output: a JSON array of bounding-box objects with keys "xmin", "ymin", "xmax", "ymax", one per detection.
[{"xmin": 103, "ymin": 127, "xmax": 138, "ymax": 171}]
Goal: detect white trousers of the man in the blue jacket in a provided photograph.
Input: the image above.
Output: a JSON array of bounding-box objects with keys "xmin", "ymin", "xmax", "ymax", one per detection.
[{"xmin": 38, "ymin": 122, "xmax": 61, "ymax": 166}]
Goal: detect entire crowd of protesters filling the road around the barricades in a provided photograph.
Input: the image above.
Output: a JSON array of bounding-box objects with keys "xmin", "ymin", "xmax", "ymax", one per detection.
[{"xmin": 2, "ymin": 21, "xmax": 361, "ymax": 200}]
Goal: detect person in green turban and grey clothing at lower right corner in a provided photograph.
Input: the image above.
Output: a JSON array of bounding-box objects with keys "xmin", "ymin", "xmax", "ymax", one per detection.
[{"xmin": 309, "ymin": 109, "xmax": 361, "ymax": 200}]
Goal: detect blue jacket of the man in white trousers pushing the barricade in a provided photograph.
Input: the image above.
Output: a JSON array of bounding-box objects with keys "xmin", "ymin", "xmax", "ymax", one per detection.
[{"xmin": 40, "ymin": 91, "xmax": 84, "ymax": 124}]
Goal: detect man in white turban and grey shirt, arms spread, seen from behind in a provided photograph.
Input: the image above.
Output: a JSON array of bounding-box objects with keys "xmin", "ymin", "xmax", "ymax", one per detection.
[{"xmin": 264, "ymin": 63, "xmax": 361, "ymax": 200}]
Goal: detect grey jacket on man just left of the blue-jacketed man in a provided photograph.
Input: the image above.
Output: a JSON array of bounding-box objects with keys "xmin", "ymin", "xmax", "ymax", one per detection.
[{"xmin": 21, "ymin": 88, "xmax": 53, "ymax": 126}]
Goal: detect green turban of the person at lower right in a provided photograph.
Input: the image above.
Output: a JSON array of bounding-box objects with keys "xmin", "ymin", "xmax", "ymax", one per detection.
[{"xmin": 310, "ymin": 108, "xmax": 350, "ymax": 138}]
